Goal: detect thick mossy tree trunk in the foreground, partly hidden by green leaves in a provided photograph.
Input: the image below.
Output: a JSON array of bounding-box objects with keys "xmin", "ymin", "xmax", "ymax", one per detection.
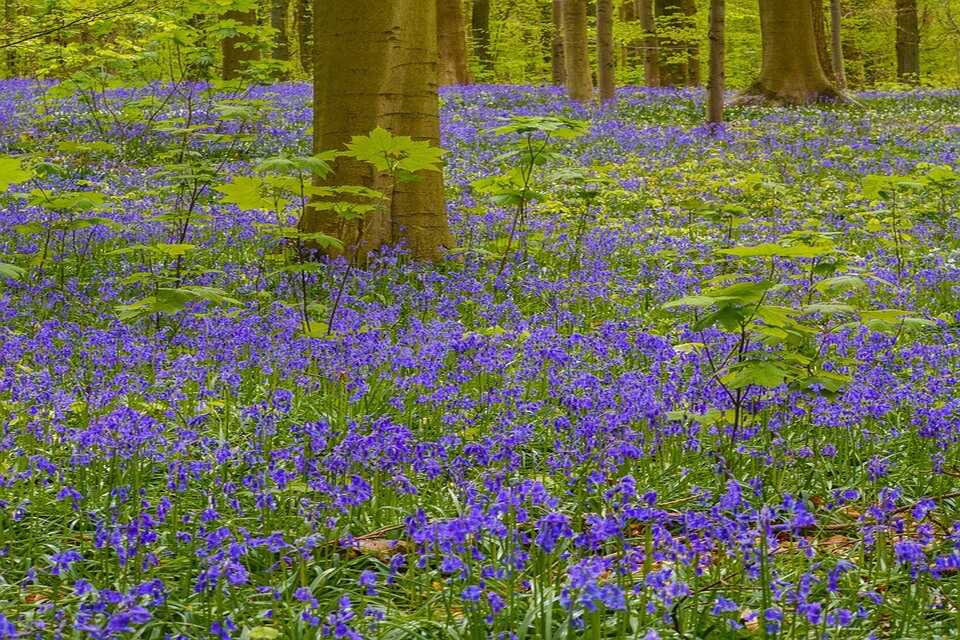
[{"xmin": 308, "ymin": 0, "xmax": 453, "ymax": 260}]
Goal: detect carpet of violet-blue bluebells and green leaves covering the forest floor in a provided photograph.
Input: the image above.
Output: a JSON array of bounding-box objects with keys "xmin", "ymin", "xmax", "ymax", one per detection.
[{"xmin": 0, "ymin": 81, "xmax": 960, "ymax": 640}]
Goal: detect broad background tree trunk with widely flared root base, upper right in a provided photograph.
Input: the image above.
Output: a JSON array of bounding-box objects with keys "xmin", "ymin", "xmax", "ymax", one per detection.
[{"xmin": 738, "ymin": 0, "xmax": 846, "ymax": 104}]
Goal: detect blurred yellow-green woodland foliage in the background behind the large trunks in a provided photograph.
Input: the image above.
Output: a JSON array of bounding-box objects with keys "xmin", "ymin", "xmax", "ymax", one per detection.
[{"xmin": 0, "ymin": 0, "xmax": 960, "ymax": 89}]
